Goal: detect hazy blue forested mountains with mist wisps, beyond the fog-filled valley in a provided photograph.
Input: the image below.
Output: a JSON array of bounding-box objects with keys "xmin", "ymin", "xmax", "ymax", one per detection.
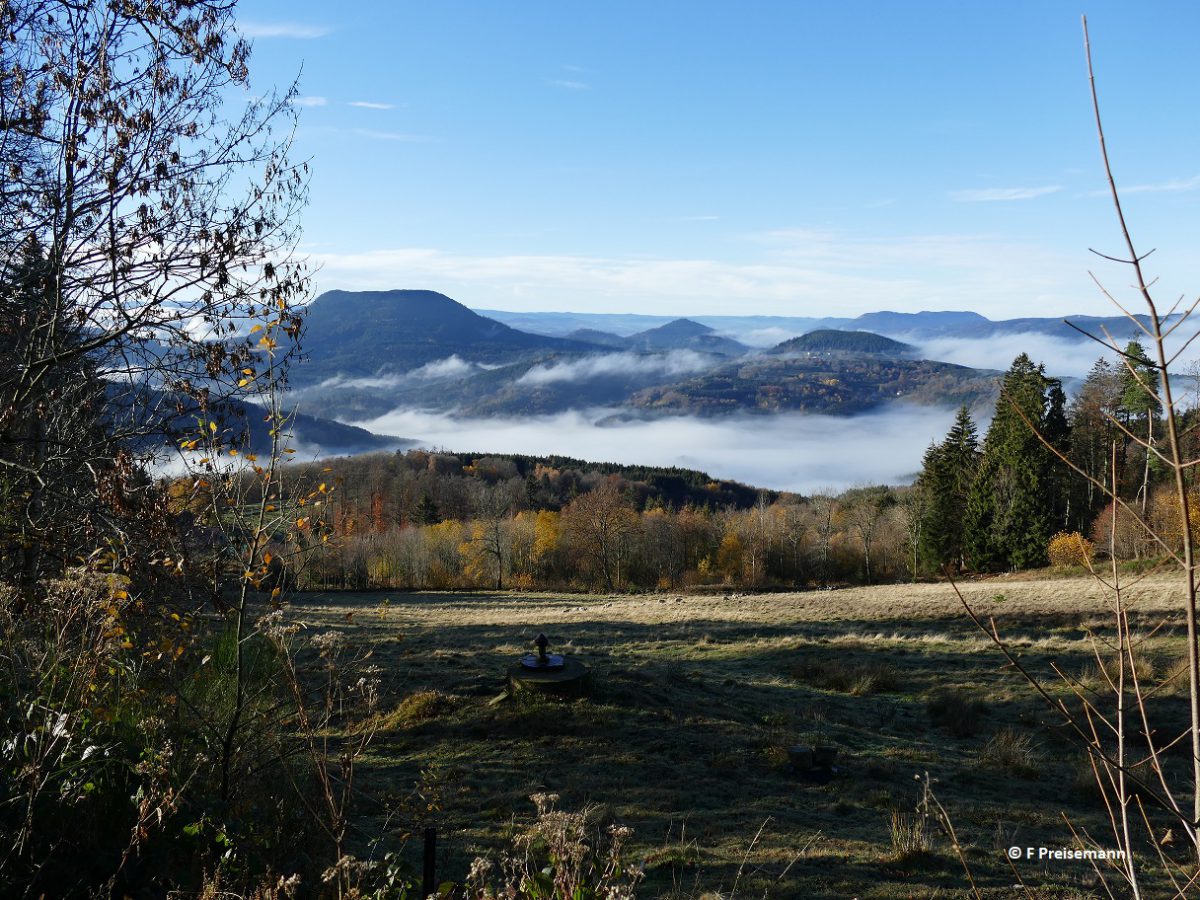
[{"xmin": 283, "ymin": 290, "xmax": 1041, "ymax": 421}]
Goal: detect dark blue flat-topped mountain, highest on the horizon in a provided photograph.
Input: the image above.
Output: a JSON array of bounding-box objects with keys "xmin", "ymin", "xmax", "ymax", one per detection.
[{"xmin": 293, "ymin": 290, "xmax": 605, "ymax": 384}]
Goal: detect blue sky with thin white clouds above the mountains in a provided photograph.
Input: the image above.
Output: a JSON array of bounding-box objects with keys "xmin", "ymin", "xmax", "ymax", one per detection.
[{"xmin": 231, "ymin": 0, "xmax": 1200, "ymax": 318}]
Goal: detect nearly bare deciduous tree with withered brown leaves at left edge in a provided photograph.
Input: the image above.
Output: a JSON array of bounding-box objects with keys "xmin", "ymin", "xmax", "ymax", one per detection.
[{"xmin": 0, "ymin": 0, "xmax": 306, "ymax": 582}]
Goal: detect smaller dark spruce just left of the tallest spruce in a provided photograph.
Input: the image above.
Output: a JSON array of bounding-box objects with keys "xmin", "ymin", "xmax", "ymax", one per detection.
[{"xmin": 917, "ymin": 406, "xmax": 979, "ymax": 570}]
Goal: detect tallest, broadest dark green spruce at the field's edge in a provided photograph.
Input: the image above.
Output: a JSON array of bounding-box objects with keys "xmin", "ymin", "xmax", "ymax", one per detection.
[{"xmin": 962, "ymin": 353, "xmax": 1069, "ymax": 571}]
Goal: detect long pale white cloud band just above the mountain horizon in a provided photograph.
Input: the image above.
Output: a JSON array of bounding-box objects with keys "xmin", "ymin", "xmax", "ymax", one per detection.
[{"xmin": 312, "ymin": 229, "xmax": 1096, "ymax": 318}]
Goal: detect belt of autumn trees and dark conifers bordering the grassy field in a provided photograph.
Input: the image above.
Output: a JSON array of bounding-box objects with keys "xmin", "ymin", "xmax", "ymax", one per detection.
[{"xmin": 236, "ymin": 342, "xmax": 1190, "ymax": 600}]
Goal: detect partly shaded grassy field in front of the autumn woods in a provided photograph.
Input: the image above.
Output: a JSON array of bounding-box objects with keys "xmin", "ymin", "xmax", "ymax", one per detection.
[{"xmin": 285, "ymin": 576, "xmax": 1187, "ymax": 898}]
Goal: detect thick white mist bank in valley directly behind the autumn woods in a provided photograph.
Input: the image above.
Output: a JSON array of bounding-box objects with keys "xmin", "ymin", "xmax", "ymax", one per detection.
[{"xmin": 355, "ymin": 403, "xmax": 954, "ymax": 493}]
